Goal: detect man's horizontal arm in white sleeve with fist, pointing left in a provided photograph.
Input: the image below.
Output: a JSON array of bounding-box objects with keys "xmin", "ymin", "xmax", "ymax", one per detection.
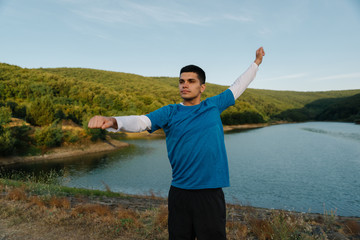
[{"xmin": 88, "ymin": 115, "xmax": 151, "ymax": 132}]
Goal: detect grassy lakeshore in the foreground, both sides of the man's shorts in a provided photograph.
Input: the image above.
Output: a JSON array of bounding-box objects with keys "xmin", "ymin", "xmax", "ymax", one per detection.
[{"xmin": 0, "ymin": 177, "xmax": 360, "ymax": 240}]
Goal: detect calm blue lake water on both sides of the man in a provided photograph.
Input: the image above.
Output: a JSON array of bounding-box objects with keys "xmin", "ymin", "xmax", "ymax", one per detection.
[{"xmin": 6, "ymin": 122, "xmax": 360, "ymax": 216}]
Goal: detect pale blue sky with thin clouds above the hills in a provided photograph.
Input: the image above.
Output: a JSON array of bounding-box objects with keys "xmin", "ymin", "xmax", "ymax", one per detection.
[{"xmin": 0, "ymin": 0, "xmax": 360, "ymax": 91}]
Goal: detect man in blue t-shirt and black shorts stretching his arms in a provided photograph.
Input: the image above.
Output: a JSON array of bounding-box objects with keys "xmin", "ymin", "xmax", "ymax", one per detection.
[{"xmin": 88, "ymin": 47, "xmax": 265, "ymax": 240}]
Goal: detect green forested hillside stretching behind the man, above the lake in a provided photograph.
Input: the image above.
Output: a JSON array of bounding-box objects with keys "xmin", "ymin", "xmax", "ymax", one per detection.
[{"xmin": 0, "ymin": 63, "xmax": 360, "ymax": 156}]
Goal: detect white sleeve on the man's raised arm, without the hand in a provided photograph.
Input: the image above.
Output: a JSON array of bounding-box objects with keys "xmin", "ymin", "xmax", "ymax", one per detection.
[{"xmin": 229, "ymin": 62, "xmax": 259, "ymax": 99}]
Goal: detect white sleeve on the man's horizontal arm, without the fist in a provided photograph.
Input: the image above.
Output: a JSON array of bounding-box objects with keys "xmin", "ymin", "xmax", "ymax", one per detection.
[{"xmin": 107, "ymin": 115, "xmax": 151, "ymax": 132}]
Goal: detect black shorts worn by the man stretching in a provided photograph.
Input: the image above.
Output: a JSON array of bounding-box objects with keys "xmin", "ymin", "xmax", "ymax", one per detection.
[{"xmin": 168, "ymin": 186, "xmax": 226, "ymax": 240}]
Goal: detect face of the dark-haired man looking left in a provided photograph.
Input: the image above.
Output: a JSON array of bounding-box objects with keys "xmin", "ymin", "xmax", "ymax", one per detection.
[{"xmin": 179, "ymin": 72, "xmax": 205, "ymax": 104}]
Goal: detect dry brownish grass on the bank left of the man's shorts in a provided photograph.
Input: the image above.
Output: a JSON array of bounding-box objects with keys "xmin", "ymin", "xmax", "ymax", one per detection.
[{"xmin": 0, "ymin": 183, "xmax": 167, "ymax": 240}]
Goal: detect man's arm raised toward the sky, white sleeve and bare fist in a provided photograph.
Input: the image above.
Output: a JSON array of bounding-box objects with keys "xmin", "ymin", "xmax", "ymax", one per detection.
[{"xmin": 229, "ymin": 47, "xmax": 265, "ymax": 99}]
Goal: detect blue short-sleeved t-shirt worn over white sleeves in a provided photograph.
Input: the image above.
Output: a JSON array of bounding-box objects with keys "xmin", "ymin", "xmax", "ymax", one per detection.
[{"xmin": 146, "ymin": 89, "xmax": 235, "ymax": 189}]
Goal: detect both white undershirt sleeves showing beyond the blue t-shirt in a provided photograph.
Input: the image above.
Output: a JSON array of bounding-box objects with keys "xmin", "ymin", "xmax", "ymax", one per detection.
[{"xmin": 107, "ymin": 63, "xmax": 258, "ymax": 132}]
